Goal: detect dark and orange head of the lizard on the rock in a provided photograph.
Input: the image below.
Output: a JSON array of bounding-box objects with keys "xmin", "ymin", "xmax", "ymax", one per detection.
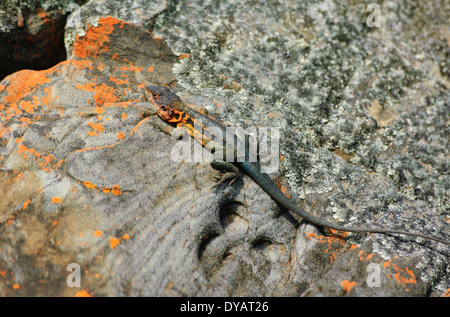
[{"xmin": 145, "ymin": 86, "xmax": 181, "ymax": 121}]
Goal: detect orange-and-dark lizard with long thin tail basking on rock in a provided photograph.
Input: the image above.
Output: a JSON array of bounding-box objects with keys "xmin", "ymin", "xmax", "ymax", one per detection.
[{"xmin": 145, "ymin": 86, "xmax": 450, "ymax": 245}]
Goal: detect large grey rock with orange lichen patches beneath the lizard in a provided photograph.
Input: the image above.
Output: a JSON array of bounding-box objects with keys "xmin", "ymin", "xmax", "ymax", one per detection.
[{"xmin": 0, "ymin": 0, "xmax": 450, "ymax": 296}]
